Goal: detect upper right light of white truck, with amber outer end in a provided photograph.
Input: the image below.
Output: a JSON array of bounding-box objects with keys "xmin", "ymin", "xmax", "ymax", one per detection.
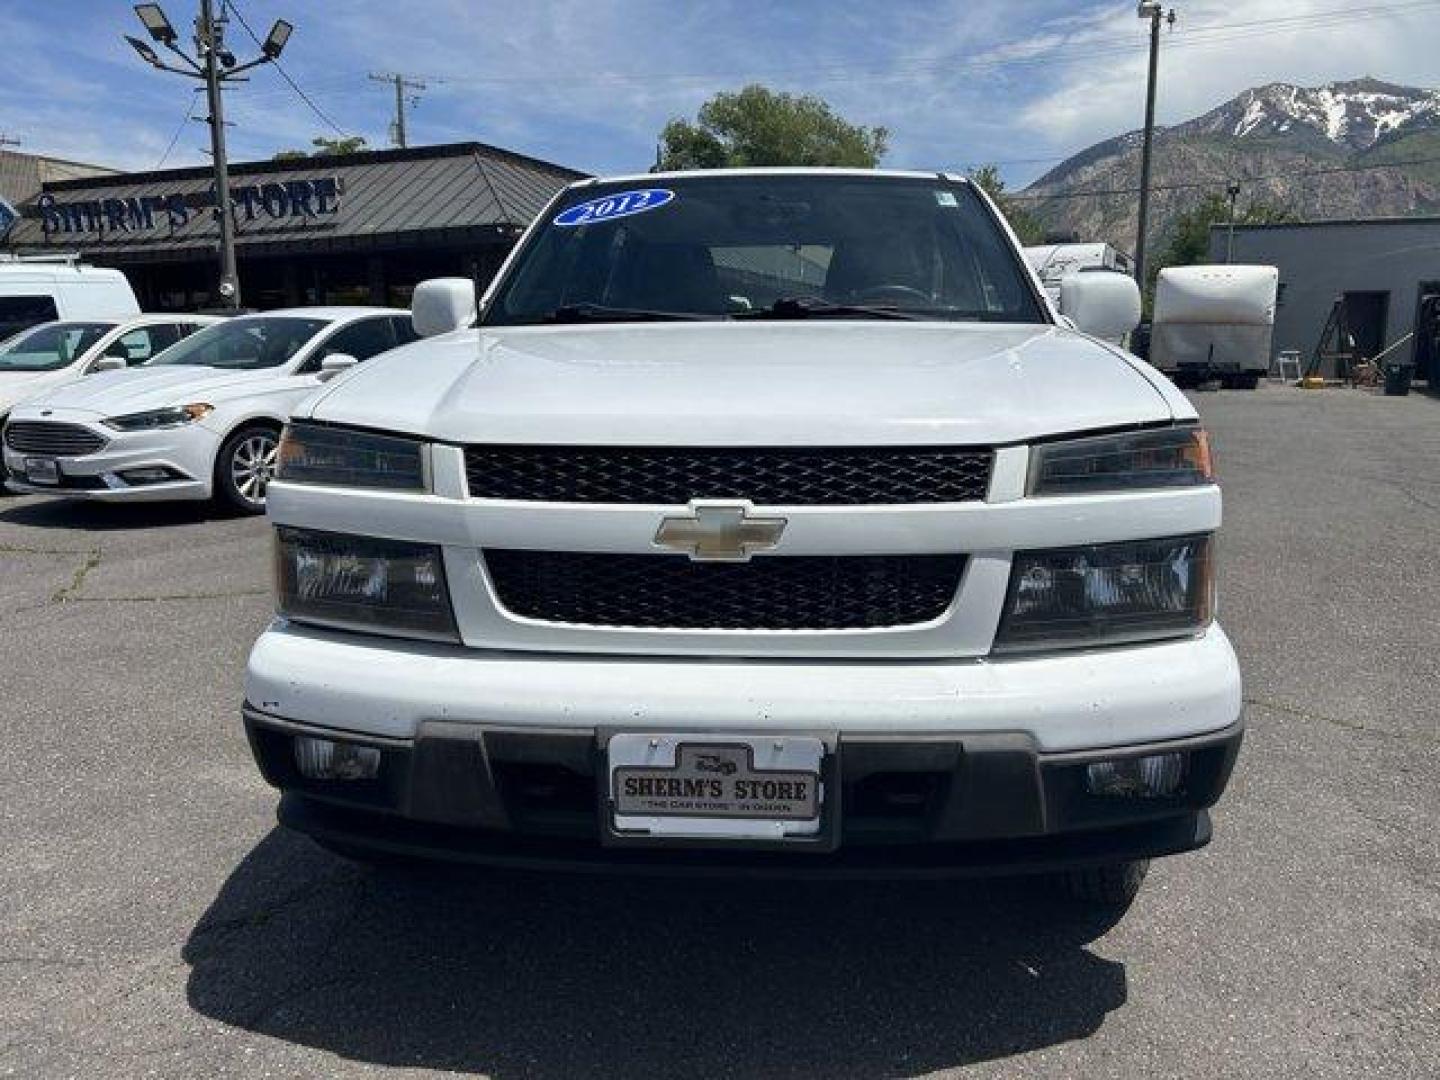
[{"xmin": 1030, "ymin": 428, "xmax": 1215, "ymax": 495}]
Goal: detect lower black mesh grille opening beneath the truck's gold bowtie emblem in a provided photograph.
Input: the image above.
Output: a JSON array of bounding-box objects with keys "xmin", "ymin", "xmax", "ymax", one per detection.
[{"xmin": 485, "ymin": 550, "xmax": 965, "ymax": 631}]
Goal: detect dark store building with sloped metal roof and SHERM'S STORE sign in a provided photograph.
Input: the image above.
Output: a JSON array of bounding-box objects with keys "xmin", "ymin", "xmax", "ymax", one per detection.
[{"xmin": 0, "ymin": 143, "xmax": 585, "ymax": 311}]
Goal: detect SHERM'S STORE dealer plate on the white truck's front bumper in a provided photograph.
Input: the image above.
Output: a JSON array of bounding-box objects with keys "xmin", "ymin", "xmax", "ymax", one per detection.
[{"xmin": 609, "ymin": 734, "xmax": 825, "ymax": 840}]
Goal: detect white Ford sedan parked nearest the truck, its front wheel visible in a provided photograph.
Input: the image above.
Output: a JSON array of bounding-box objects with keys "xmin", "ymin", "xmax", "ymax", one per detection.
[{"xmin": 4, "ymin": 307, "xmax": 416, "ymax": 514}]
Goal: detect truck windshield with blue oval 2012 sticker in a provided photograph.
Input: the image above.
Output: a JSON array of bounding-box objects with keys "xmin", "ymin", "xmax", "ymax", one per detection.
[{"xmin": 484, "ymin": 174, "xmax": 1044, "ymax": 325}]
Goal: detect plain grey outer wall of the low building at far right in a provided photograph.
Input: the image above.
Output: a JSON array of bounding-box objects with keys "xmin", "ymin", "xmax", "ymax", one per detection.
[{"xmin": 1210, "ymin": 217, "xmax": 1440, "ymax": 374}]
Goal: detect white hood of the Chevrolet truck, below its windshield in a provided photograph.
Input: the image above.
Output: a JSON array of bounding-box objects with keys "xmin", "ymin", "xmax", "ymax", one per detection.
[{"xmin": 310, "ymin": 320, "xmax": 1185, "ymax": 446}]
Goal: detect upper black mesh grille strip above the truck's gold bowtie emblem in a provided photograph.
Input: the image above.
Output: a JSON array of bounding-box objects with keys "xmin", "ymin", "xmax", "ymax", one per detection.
[{"xmin": 465, "ymin": 445, "xmax": 995, "ymax": 505}]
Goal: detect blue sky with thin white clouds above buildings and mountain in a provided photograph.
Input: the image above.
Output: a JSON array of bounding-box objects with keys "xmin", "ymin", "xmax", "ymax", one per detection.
[{"xmin": 0, "ymin": 0, "xmax": 1440, "ymax": 186}]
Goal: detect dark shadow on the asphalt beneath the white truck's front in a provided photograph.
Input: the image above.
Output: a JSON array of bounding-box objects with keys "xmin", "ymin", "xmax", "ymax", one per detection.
[{"xmin": 184, "ymin": 829, "xmax": 1126, "ymax": 1080}]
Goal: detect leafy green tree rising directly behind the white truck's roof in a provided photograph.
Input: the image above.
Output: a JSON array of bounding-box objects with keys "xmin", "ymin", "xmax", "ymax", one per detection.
[{"xmin": 660, "ymin": 85, "xmax": 890, "ymax": 168}]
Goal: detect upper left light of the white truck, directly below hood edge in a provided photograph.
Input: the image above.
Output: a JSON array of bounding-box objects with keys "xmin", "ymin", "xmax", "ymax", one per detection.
[{"xmin": 275, "ymin": 423, "xmax": 425, "ymax": 491}]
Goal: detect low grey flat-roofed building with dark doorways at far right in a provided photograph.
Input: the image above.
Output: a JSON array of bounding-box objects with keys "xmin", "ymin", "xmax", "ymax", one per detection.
[{"xmin": 1210, "ymin": 217, "xmax": 1440, "ymax": 386}]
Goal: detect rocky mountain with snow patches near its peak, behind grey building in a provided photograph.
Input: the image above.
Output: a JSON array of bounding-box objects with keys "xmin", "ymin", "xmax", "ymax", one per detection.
[{"xmin": 1024, "ymin": 78, "xmax": 1440, "ymax": 251}]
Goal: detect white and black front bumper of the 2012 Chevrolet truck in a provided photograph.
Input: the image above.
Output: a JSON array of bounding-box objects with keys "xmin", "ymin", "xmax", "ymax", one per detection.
[{"xmin": 245, "ymin": 622, "xmax": 1241, "ymax": 874}]
